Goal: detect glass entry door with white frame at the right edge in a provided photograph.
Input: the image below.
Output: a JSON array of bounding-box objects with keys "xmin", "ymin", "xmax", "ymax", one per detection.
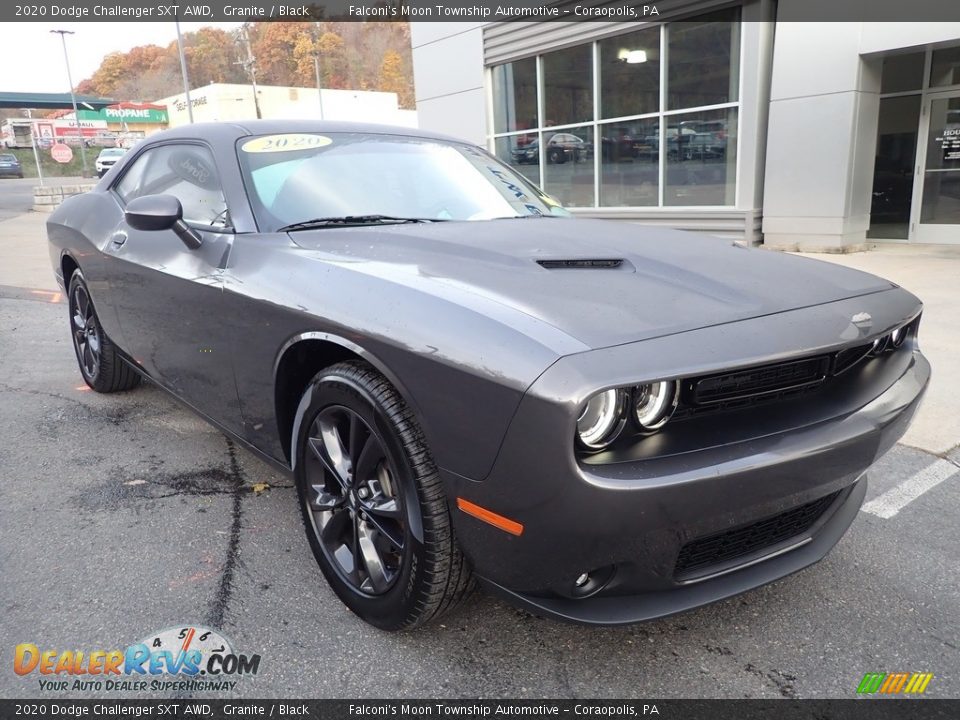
[{"xmin": 911, "ymin": 90, "xmax": 960, "ymax": 244}]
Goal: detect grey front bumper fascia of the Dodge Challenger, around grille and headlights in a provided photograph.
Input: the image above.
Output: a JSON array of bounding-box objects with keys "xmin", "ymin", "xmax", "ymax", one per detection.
[{"xmin": 443, "ymin": 290, "xmax": 930, "ymax": 624}]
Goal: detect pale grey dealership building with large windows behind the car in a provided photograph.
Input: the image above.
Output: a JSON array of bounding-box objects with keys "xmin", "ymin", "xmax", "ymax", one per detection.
[{"xmin": 411, "ymin": 5, "xmax": 960, "ymax": 252}]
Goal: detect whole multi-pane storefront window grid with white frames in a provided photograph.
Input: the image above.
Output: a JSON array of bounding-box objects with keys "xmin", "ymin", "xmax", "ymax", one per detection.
[{"xmin": 490, "ymin": 7, "xmax": 740, "ymax": 208}]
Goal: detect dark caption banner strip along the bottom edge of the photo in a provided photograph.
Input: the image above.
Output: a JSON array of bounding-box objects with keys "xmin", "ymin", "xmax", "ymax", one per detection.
[{"xmin": 0, "ymin": 699, "xmax": 960, "ymax": 720}]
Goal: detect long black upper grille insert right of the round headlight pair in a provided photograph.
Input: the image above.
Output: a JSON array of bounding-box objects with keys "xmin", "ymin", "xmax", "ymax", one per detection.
[{"xmin": 692, "ymin": 355, "xmax": 830, "ymax": 405}]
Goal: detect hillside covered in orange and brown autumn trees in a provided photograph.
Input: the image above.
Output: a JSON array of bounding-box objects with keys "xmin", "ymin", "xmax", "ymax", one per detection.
[{"xmin": 76, "ymin": 22, "xmax": 414, "ymax": 109}]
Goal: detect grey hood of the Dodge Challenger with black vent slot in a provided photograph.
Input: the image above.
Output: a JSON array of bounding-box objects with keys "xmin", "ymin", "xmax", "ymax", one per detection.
[{"xmin": 290, "ymin": 218, "xmax": 895, "ymax": 349}]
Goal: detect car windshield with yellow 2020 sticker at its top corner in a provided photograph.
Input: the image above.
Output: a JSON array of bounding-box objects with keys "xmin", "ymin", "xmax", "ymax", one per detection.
[{"xmin": 238, "ymin": 133, "xmax": 569, "ymax": 232}]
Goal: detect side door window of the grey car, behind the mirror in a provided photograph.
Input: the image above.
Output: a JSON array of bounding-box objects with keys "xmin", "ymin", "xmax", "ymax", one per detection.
[{"xmin": 114, "ymin": 144, "xmax": 230, "ymax": 228}]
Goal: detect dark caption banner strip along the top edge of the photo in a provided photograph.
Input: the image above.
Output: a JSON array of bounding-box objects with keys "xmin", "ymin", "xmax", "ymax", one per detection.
[{"xmin": 0, "ymin": 0, "xmax": 960, "ymax": 22}]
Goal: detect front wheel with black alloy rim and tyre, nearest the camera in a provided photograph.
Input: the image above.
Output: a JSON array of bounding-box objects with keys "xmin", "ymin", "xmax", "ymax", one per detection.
[{"xmin": 295, "ymin": 361, "xmax": 474, "ymax": 630}]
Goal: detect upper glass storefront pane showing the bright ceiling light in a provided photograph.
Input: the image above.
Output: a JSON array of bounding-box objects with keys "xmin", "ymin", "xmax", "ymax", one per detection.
[{"xmin": 599, "ymin": 27, "xmax": 660, "ymax": 118}]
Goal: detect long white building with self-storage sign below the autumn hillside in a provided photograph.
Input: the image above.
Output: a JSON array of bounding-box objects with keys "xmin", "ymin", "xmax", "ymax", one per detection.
[{"xmin": 155, "ymin": 83, "xmax": 417, "ymax": 127}]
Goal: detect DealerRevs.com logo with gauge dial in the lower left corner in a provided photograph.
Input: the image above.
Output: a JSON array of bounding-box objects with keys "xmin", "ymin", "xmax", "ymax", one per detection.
[{"xmin": 13, "ymin": 625, "xmax": 260, "ymax": 692}]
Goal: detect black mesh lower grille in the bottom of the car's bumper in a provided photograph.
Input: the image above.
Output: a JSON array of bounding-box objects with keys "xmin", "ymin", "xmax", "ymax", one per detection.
[{"xmin": 675, "ymin": 491, "xmax": 839, "ymax": 579}]
